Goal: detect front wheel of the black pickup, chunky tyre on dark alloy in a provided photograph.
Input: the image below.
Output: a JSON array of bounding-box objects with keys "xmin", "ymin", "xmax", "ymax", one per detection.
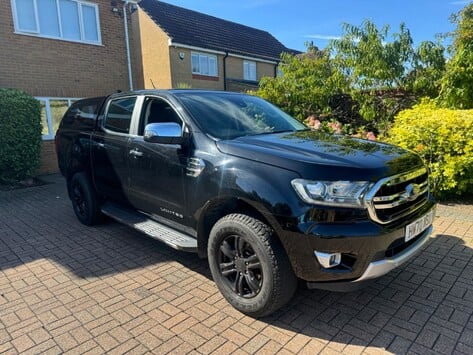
[{"xmin": 208, "ymin": 214, "xmax": 297, "ymax": 317}]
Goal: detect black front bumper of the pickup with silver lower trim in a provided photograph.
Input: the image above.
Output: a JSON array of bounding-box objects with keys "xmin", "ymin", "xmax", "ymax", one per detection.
[{"xmin": 281, "ymin": 201, "xmax": 435, "ymax": 291}]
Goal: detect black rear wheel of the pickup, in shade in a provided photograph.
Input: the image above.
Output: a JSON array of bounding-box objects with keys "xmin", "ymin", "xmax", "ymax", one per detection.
[{"xmin": 70, "ymin": 173, "xmax": 101, "ymax": 226}]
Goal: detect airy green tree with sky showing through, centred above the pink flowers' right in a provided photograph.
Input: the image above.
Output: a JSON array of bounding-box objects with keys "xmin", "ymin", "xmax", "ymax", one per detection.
[{"xmin": 330, "ymin": 20, "xmax": 445, "ymax": 133}]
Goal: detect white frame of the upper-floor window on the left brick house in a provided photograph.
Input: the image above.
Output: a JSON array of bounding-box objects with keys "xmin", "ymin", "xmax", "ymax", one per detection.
[{"xmin": 11, "ymin": 0, "xmax": 102, "ymax": 45}]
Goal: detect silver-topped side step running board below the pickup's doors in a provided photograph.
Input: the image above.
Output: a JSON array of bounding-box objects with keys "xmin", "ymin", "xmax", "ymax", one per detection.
[{"xmin": 102, "ymin": 202, "xmax": 197, "ymax": 252}]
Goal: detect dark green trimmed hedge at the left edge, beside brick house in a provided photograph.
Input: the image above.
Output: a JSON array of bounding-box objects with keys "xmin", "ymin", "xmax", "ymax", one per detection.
[{"xmin": 0, "ymin": 88, "xmax": 42, "ymax": 183}]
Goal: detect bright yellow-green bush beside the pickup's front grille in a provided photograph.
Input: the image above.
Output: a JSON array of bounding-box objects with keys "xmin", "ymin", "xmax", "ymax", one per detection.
[{"xmin": 387, "ymin": 100, "xmax": 473, "ymax": 196}]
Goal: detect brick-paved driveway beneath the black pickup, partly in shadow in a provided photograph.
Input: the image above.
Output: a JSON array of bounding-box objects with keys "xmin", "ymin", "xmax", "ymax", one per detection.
[{"xmin": 0, "ymin": 176, "xmax": 473, "ymax": 354}]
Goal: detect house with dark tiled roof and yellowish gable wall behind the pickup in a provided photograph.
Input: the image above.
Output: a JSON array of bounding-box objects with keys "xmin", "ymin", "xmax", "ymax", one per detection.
[{"xmin": 132, "ymin": 0, "xmax": 294, "ymax": 91}]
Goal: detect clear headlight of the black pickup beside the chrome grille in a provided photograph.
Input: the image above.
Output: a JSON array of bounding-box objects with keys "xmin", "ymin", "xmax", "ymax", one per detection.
[{"xmin": 291, "ymin": 179, "xmax": 371, "ymax": 208}]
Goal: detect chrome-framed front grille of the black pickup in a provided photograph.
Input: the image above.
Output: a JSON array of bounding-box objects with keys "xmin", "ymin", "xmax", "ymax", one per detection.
[{"xmin": 365, "ymin": 168, "xmax": 429, "ymax": 224}]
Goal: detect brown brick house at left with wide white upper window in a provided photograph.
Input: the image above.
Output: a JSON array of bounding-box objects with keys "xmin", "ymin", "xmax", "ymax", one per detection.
[{"xmin": 0, "ymin": 0, "xmax": 138, "ymax": 173}]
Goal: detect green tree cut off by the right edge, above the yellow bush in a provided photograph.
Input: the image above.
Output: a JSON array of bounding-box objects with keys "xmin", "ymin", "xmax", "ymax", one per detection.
[{"xmin": 439, "ymin": 3, "xmax": 473, "ymax": 109}]
